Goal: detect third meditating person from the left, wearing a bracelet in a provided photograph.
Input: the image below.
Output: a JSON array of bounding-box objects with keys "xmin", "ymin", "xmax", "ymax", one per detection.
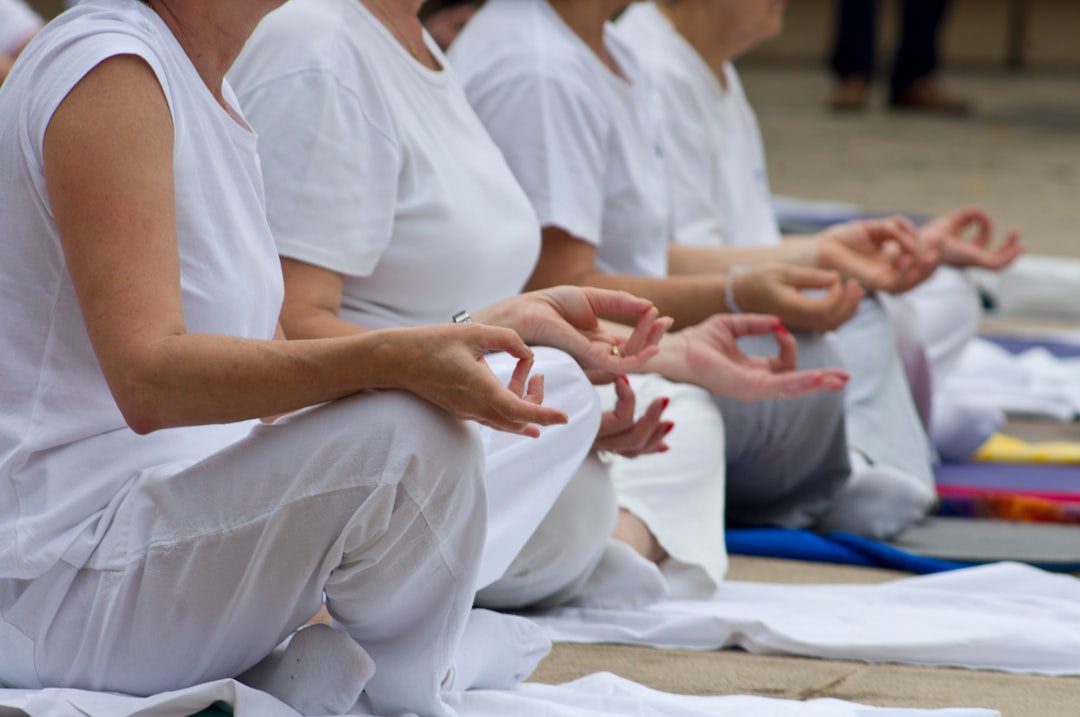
[{"xmin": 450, "ymin": 0, "xmax": 950, "ymax": 565}]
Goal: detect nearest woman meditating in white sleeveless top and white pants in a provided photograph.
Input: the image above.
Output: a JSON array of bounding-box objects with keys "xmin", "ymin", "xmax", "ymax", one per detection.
[{"xmin": 0, "ymin": 0, "xmax": 656, "ymax": 715}]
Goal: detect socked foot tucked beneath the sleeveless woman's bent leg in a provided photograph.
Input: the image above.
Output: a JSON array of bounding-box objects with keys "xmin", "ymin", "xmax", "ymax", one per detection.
[{"xmin": 237, "ymin": 625, "xmax": 375, "ymax": 715}]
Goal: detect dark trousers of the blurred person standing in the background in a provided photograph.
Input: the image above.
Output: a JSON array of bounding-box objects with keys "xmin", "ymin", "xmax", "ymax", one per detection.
[{"xmin": 833, "ymin": 0, "xmax": 949, "ymax": 98}]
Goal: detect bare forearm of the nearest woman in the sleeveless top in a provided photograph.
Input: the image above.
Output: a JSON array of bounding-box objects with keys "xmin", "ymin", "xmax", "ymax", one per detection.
[{"xmin": 111, "ymin": 329, "xmax": 403, "ymax": 433}]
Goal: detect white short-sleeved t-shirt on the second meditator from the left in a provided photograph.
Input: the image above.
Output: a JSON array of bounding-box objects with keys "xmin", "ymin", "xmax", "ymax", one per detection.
[{"xmin": 230, "ymin": 0, "xmax": 540, "ymax": 328}]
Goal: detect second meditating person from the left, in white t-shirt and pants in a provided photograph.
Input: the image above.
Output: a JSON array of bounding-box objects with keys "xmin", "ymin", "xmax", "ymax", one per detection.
[{"xmin": 230, "ymin": 0, "xmax": 846, "ymax": 609}]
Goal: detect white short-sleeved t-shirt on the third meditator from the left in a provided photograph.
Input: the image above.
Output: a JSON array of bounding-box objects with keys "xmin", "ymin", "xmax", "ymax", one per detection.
[{"xmin": 450, "ymin": 0, "xmax": 671, "ymax": 276}]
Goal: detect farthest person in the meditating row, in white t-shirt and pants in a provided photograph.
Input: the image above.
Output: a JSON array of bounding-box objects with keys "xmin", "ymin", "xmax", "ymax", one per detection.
[{"xmin": 619, "ymin": 0, "xmax": 1024, "ymax": 459}]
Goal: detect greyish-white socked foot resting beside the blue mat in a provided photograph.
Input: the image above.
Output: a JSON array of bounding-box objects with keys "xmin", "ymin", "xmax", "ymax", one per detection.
[{"xmin": 819, "ymin": 451, "xmax": 936, "ymax": 540}]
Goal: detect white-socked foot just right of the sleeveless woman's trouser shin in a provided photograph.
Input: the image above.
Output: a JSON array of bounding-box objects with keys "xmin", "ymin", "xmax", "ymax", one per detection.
[{"xmin": 446, "ymin": 609, "xmax": 551, "ymax": 692}]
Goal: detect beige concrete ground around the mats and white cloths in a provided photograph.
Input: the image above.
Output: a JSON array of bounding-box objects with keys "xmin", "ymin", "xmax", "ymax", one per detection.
[{"xmin": 534, "ymin": 66, "xmax": 1080, "ymax": 717}]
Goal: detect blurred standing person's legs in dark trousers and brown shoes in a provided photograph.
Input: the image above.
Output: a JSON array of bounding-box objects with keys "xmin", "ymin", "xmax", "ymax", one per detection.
[{"xmin": 829, "ymin": 0, "xmax": 971, "ymax": 114}]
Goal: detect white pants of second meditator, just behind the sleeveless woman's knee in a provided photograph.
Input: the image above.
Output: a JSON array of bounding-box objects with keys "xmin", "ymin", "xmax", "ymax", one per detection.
[{"xmin": 477, "ymin": 348, "xmax": 613, "ymax": 591}]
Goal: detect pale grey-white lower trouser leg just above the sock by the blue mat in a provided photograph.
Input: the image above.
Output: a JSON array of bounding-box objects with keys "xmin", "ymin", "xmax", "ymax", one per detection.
[{"xmin": 834, "ymin": 297, "xmax": 934, "ymax": 485}]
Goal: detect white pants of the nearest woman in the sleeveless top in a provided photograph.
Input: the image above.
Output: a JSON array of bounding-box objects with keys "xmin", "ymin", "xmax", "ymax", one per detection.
[{"xmin": 0, "ymin": 393, "xmax": 485, "ymax": 715}]
